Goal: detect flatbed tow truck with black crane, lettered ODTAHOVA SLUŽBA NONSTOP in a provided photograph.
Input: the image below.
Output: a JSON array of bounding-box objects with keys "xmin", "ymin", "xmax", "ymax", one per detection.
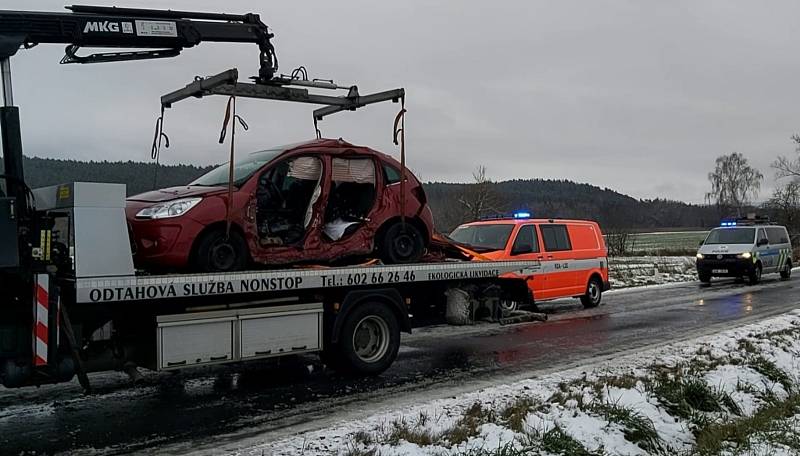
[{"xmin": 0, "ymin": 6, "xmax": 541, "ymax": 392}]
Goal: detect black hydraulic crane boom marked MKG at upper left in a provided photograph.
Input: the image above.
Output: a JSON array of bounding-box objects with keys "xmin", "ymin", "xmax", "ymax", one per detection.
[{"xmin": 0, "ymin": 5, "xmax": 278, "ymax": 79}]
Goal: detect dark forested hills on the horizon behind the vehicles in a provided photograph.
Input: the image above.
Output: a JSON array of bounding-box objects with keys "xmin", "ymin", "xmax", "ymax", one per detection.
[{"xmin": 15, "ymin": 157, "xmax": 718, "ymax": 233}]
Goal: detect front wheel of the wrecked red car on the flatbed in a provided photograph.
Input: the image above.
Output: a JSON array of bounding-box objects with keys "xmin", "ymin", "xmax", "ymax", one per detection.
[{"xmin": 192, "ymin": 229, "xmax": 249, "ymax": 272}]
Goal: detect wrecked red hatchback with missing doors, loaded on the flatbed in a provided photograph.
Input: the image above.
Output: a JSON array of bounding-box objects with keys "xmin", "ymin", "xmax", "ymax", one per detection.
[{"xmin": 126, "ymin": 139, "xmax": 433, "ymax": 272}]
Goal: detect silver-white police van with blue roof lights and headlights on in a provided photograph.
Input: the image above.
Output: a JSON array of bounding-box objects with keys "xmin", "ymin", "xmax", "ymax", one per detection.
[{"xmin": 697, "ymin": 216, "xmax": 792, "ymax": 285}]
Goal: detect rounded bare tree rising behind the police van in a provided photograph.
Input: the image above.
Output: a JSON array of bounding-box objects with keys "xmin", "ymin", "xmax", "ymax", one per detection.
[{"xmin": 706, "ymin": 152, "xmax": 764, "ymax": 216}]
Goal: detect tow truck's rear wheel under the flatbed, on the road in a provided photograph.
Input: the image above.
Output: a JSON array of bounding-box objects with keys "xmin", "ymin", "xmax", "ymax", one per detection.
[{"xmin": 328, "ymin": 302, "xmax": 400, "ymax": 375}]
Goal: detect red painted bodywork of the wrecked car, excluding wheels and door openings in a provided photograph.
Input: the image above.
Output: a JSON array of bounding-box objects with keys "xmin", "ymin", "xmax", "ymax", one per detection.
[{"xmin": 126, "ymin": 139, "xmax": 433, "ymax": 269}]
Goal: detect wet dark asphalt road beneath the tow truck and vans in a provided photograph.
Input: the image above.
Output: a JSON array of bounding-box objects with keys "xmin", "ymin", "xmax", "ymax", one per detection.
[{"xmin": 0, "ymin": 276, "xmax": 800, "ymax": 454}]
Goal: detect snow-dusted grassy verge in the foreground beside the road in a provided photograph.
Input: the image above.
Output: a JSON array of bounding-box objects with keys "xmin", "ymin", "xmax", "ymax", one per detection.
[{"xmin": 255, "ymin": 310, "xmax": 800, "ymax": 456}]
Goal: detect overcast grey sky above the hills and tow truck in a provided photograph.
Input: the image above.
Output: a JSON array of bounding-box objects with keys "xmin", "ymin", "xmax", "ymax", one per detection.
[{"xmin": 2, "ymin": 0, "xmax": 800, "ymax": 202}]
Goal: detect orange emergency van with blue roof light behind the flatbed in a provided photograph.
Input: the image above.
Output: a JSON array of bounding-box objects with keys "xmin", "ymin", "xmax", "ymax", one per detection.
[{"xmin": 450, "ymin": 213, "xmax": 610, "ymax": 308}]
